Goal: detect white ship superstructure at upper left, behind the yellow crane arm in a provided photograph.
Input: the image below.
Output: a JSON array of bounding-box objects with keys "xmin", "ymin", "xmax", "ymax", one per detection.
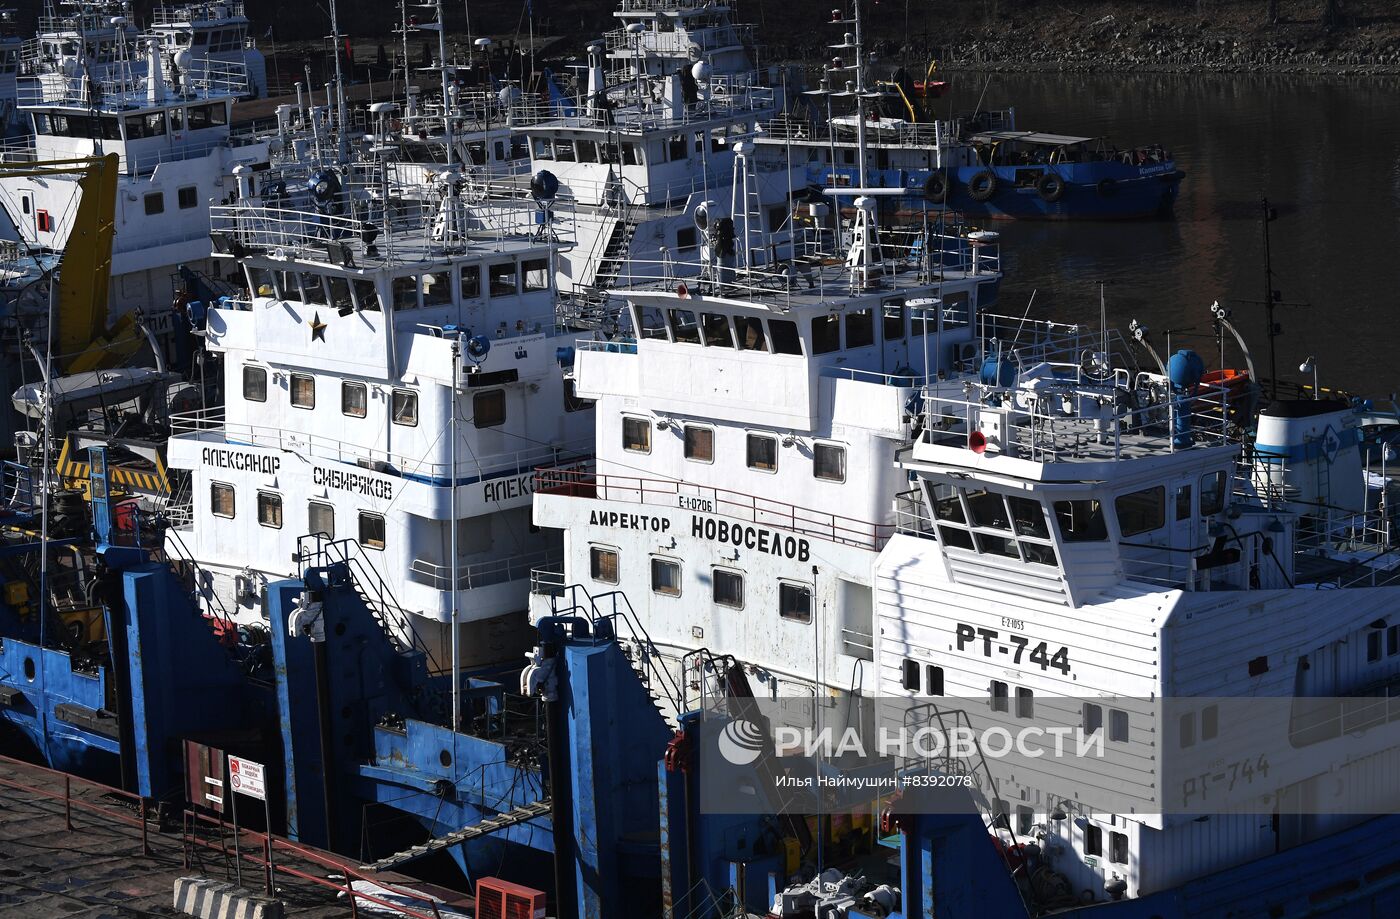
[{"xmin": 0, "ymin": 34, "xmax": 269, "ymax": 339}]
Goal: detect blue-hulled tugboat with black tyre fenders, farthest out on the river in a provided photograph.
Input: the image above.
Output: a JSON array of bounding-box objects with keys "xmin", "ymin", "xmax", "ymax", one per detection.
[{"xmin": 757, "ymin": 3, "xmax": 1184, "ymax": 220}]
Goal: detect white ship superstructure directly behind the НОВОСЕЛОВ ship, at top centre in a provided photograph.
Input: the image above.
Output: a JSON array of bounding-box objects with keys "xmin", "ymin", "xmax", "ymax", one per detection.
[{"xmin": 487, "ymin": 1, "xmax": 804, "ymax": 307}]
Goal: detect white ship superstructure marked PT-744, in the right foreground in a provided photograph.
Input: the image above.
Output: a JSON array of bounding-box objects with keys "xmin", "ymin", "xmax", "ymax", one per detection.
[{"xmin": 874, "ymin": 352, "xmax": 1400, "ymax": 902}]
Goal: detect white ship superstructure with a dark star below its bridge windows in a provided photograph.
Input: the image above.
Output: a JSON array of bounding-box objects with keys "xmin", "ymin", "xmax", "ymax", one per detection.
[{"xmin": 168, "ymin": 166, "xmax": 592, "ymax": 667}]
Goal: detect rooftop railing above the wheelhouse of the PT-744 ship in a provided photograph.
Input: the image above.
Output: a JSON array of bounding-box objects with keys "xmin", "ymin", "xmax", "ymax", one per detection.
[{"xmin": 921, "ymin": 361, "xmax": 1238, "ymax": 462}]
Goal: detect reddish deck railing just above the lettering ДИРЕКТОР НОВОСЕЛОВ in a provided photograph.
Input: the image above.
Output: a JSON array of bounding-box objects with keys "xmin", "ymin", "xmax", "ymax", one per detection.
[{"xmin": 535, "ymin": 465, "xmax": 895, "ymax": 549}]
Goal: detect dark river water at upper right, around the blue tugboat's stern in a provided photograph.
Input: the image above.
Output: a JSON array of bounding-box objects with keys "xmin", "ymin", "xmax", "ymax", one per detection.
[{"xmin": 952, "ymin": 73, "xmax": 1400, "ymax": 396}]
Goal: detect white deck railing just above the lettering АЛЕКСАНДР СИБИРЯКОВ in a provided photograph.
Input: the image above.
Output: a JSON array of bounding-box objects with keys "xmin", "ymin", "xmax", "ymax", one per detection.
[{"xmin": 171, "ymin": 408, "xmax": 594, "ymax": 486}]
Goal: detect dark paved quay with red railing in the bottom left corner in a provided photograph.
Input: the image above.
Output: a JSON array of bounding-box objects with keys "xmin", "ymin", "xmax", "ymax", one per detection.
[{"xmin": 0, "ymin": 758, "xmax": 468, "ymax": 919}]
